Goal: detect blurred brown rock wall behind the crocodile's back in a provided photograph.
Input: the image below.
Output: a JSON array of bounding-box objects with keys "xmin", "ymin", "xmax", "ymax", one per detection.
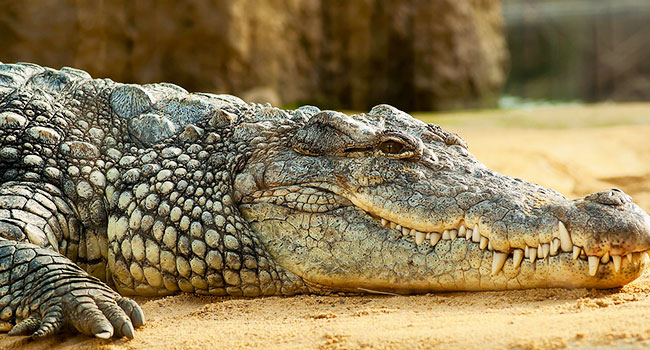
[{"xmin": 0, "ymin": 0, "xmax": 507, "ymax": 110}]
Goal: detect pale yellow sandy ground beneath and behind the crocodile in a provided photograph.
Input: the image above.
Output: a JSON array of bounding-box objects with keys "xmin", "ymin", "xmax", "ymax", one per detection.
[{"xmin": 0, "ymin": 104, "xmax": 650, "ymax": 350}]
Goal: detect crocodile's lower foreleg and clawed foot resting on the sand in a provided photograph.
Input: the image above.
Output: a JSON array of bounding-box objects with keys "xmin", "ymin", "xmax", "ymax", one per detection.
[{"xmin": 0, "ymin": 240, "xmax": 144, "ymax": 338}]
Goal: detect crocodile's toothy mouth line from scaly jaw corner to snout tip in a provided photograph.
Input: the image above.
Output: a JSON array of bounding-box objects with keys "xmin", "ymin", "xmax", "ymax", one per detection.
[{"xmin": 242, "ymin": 184, "xmax": 650, "ymax": 276}]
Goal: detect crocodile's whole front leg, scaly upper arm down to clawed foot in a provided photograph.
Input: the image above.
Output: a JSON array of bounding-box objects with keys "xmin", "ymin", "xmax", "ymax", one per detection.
[{"xmin": 0, "ymin": 182, "xmax": 144, "ymax": 338}]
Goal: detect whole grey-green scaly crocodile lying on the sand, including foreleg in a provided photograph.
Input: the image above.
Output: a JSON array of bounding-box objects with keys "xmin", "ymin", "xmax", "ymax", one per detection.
[{"xmin": 0, "ymin": 63, "xmax": 650, "ymax": 338}]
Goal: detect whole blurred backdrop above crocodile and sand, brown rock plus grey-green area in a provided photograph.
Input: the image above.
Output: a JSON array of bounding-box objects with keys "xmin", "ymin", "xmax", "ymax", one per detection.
[{"xmin": 0, "ymin": 0, "xmax": 650, "ymax": 111}]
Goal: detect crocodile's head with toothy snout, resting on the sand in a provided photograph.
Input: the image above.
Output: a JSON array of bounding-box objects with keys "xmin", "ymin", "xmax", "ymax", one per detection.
[{"xmin": 235, "ymin": 105, "xmax": 650, "ymax": 293}]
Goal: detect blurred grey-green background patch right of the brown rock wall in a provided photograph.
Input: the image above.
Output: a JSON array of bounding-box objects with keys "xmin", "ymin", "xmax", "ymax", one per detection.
[{"xmin": 502, "ymin": 0, "xmax": 650, "ymax": 102}]
